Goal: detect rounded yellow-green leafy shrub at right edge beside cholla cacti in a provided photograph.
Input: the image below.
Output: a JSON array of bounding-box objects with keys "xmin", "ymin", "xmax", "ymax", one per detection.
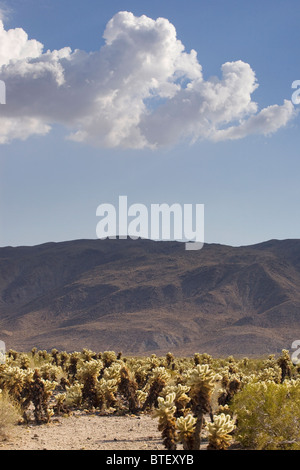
[{"xmin": 232, "ymin": 380, "xmax": 300, "ymax": 450}]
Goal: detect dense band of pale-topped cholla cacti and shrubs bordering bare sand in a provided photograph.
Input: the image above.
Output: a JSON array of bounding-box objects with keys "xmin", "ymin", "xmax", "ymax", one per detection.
[{"xmin": 0, "ymin": 348, "xmax": 300, "ymax": 450}]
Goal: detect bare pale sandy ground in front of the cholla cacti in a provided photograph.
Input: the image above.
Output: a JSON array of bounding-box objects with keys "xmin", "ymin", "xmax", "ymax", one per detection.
[{"xmin": 0, "ymin": 413, "xmax": 188, "ymax": 450}]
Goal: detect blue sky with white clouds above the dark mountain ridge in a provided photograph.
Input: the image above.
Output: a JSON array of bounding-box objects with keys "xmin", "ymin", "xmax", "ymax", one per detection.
[{"xmin": 0, "ymin": 0, "xmax": 300, "ymax": 246}]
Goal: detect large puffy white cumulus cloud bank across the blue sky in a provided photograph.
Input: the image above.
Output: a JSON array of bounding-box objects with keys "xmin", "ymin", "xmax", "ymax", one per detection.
[{"xmin": 0, "ymin": 12, "xmax": 294, "ymax": 148}]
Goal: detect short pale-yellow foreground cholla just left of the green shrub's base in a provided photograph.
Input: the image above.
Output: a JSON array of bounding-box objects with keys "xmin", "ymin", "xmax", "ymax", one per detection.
[{"xmin": 206, "ymin": 413, "xmax": 235, "ymax": 450}]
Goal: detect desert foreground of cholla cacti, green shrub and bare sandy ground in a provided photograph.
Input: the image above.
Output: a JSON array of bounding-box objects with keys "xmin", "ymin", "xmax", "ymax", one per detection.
[{"xmin": 0, "ymin": 348, "xmax": 300, "ymax": 451}]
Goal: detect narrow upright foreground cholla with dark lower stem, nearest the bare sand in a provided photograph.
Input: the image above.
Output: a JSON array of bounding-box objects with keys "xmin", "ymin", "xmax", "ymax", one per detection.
[{"xmin": 153, "ymin": 393, "xmax": 176, "ymax": 450}]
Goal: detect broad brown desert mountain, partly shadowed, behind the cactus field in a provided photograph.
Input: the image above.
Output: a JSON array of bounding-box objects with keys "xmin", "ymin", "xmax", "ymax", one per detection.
[{"xmin": 0, "ymin": 239, "xmax": 300, "ymax": 356}]
